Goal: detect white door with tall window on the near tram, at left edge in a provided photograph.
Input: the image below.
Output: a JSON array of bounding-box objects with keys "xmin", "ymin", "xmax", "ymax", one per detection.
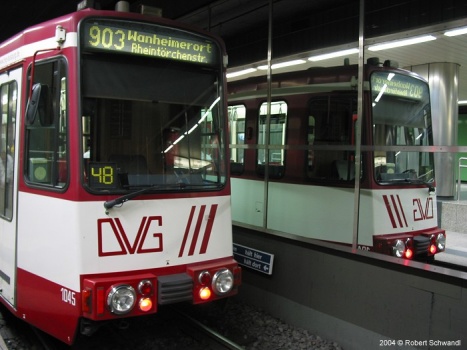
[{"xmin": 0, "ymin": 68, "xmax": 22, "ymax": 306}]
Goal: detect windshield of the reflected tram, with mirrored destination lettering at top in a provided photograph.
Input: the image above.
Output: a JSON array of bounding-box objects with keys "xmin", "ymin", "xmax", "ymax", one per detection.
[{"xmin": 371, "ymin": 72, "xmax": 434, "ymax": 184}]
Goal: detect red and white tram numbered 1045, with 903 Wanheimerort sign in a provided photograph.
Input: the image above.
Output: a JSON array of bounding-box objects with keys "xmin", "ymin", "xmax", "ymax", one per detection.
[{"xmin": 0, "ymin": 0, "xmax": 241, "ymax": 344}]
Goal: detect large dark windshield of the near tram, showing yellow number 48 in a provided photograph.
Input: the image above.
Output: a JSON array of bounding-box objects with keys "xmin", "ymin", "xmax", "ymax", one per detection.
[{"xmin": 81, "ymin": 20, "xmax": 226, "ymax": 192}]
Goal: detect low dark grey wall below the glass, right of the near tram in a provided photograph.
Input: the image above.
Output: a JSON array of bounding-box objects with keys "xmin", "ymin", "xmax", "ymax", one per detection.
[{"xmin": 234, "ymin": 227, "xmax": 467, "ymax": 350}]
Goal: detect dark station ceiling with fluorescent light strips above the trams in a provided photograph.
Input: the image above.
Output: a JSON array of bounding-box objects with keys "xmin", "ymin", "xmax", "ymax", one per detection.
[{"xmin": 0, "ymin": 0, "xmax": 467, "ymax": 100}]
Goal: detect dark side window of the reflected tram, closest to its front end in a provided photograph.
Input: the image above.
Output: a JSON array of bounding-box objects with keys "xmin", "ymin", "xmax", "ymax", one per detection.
[{"xmin": 306, "ymin": 96, "xmax": 357, "ymax": 181}]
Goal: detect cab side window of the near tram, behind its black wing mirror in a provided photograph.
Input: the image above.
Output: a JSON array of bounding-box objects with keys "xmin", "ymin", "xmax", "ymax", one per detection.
[{"xmin": 25, "ymin": 60, "xmax": 68, "ymax": 188}]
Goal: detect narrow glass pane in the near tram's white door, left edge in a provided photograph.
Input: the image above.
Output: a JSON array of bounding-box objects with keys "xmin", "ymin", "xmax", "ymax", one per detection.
[{"xmin": 0, "ymin": 81, "xmax": 18, "ymax": 219}]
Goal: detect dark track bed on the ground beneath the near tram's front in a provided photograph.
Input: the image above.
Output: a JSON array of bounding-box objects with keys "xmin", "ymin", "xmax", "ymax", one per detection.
[{"xmin": 1, "ymin": 307, "xmax": 244, "ymax": 350}]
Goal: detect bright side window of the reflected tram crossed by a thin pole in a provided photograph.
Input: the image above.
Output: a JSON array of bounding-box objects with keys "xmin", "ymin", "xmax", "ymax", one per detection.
[{"xmin": 257, "ymin": 101, "xmax": 287, "ymax": 179}]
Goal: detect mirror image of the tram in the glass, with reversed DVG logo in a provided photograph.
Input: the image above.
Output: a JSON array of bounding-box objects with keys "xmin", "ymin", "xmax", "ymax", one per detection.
[{"xmin": 228, "ymin": 60, "xmax": 445, "ymax": 259}]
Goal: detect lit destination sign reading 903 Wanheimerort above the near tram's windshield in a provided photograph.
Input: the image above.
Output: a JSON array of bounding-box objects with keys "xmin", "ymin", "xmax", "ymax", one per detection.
[{"xmin": 83, "ymin": 21, "xmax": 217, "ymax": 65}]
